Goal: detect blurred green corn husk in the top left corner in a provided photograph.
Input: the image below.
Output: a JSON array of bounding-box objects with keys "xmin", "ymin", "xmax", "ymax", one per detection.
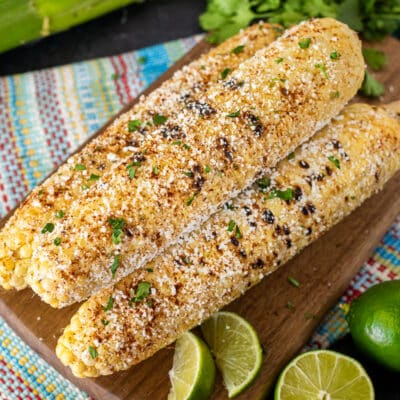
[{"xmin": 0, "ymin": 0, "xmax": 143, "ymax": 53}]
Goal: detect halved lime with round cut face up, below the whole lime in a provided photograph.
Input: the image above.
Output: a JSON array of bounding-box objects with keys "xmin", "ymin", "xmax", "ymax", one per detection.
[{"xmin": 275, "ymin": 350, "xmax": 375, "ymax": 400}]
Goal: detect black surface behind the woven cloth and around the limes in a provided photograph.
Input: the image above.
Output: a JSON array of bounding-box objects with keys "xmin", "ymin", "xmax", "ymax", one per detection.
[{"xmin": 0, "ymin": 0, "xmax": 400, "ymax": 400}]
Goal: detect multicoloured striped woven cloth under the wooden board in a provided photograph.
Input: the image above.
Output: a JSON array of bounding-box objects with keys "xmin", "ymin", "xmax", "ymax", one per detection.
[{"xmin": 0, "ymin": 36, "xmax": 400, "ymax": 400}]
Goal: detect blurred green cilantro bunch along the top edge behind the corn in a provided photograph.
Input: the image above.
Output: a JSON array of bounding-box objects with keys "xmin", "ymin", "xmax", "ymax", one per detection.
[{"xmin": 200, "ymin": 0, "xmax": 400, "ymax": 43}]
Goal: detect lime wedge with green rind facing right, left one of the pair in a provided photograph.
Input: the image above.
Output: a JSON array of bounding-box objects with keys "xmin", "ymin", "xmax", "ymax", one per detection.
[{"xmin": 168, "ymin": 332, "xmax": 215, "ymax": 400}]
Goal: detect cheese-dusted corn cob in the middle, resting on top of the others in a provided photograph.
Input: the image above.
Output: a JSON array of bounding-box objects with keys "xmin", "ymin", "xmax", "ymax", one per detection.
[{"xmin": 7, "ymin": 19, "xmax": 363, "ymax": 306}]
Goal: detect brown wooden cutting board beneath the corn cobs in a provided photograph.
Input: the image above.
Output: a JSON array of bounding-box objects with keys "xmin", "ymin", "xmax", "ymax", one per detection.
[{"xmin": 0, "ymin": 38, "xmax": 400, "ymax": 400}]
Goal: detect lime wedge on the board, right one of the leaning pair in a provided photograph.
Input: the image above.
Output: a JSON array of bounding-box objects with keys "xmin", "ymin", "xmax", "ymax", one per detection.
[{"xmin": 201, "ymin": 311, "xmax": 262, "ymax": 398}]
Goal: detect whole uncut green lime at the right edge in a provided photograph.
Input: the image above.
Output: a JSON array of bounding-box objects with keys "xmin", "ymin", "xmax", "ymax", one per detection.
[{"xmin": 347, "ymin": 280, "xmax": 400, "ymax": 372}]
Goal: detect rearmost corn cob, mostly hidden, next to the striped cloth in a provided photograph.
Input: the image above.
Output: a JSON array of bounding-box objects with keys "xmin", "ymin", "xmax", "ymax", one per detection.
[{"xmin": 0, "ymin": 23, "xmax": 281, "ymax": 289}]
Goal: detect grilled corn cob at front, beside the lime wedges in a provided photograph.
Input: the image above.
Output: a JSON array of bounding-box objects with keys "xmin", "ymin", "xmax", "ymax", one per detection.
[{"xmin": 56, "ymin": 104, "xmax": 400, "ymax": 377}]
